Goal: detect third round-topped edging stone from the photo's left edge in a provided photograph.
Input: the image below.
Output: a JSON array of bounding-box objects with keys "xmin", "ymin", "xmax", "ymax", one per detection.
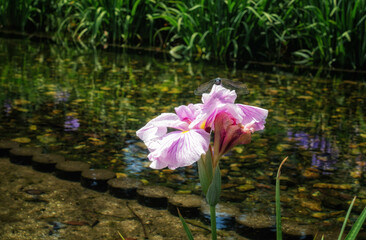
[{"xmin": 32, "ymin": 154, "xmax": 65, "ymax": 172}]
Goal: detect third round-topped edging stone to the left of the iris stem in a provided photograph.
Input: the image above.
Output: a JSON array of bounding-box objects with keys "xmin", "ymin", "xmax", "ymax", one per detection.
[{"xmin": 107, "ymin": 178, "xmax": 142, "ymax": 199}]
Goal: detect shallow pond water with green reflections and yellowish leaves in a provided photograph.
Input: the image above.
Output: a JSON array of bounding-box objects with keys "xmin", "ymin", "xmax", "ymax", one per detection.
[{"xmin": 0, "ymin": 36, "xmax": 366, "ymax": 237}]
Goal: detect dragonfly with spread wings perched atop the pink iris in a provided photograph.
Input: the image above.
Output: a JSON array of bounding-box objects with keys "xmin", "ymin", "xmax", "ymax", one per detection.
[{"xmin": 194, "ymin": 78, "xmax": 249, "ymax": 95}]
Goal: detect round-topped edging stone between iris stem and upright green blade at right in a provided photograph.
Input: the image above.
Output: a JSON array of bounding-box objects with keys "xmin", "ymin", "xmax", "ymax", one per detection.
[{"xmin": 236, "ymin": 213, "xmax": 276, "ymax": 240}]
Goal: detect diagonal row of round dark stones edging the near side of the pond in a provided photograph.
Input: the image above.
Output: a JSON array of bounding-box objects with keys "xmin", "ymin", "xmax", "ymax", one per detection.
[{"xmin": 0, "ymin": 139, "xmax": 346, "ymax": 240}]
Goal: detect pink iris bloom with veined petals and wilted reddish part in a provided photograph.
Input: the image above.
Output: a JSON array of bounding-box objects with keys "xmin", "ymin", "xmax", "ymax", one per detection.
[{"xmin": 136, "ymin": 85, "xmax": 268, "ymax": 169}]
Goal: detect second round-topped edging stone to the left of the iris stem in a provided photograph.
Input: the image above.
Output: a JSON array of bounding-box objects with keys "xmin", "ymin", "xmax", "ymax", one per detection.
[{"xmin": 137, "ymin": 186, "xmax": 174, "ymax": 209}]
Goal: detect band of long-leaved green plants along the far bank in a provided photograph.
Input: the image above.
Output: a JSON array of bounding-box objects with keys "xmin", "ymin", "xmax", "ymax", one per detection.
[{"xmin": 0, "ymin": 0, "xmax": 366, "ymax": 69}]
